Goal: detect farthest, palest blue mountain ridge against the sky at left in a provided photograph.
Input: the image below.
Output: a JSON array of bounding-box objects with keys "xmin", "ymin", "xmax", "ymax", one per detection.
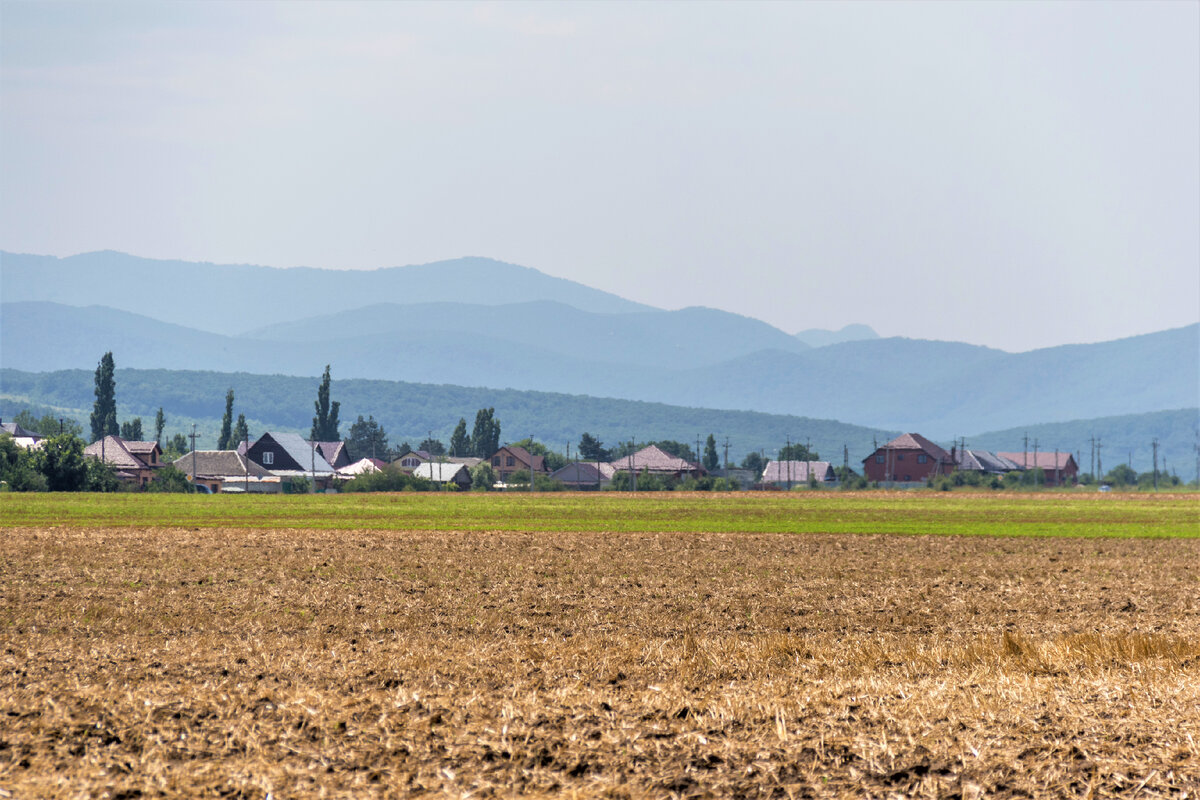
[{"xmin": 0, "ymin": 251, "xmax": 653, "ymax": 336}]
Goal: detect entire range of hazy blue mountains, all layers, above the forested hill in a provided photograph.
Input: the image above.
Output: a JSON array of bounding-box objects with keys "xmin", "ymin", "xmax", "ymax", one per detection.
[{"xmin": 0, "ymin": 252, "xmax": 1200, "ymax": 438}]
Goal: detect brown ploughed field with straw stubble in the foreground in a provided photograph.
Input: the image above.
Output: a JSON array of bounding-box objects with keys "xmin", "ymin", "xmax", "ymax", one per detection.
[{"xmin": 0, "ymin": 529, "xmax": 1200, "ymax": 800}]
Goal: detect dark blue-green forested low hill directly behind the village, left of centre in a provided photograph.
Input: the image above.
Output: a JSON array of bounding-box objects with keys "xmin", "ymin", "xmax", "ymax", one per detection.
[{"xmin": 0, "ymin": 368, "xmax": 896, "ymax": 465}]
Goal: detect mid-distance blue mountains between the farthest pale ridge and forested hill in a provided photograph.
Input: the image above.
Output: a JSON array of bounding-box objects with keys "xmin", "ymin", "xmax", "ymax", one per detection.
[{"xmin": 0, "ymin": 303, "xmax": 1200, "ymax": 438}]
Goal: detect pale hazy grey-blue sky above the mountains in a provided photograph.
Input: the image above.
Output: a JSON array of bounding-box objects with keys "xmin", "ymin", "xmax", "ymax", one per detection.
[{"xmin": 0, "ymin": 0, "xmax": 1200, "ymax": 350}]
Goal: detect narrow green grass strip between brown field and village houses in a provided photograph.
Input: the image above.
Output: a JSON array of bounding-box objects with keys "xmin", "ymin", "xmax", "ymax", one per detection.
[{"xmin": 0, "ymin": 492, "xmax": 1200, "ymax": 539}]
